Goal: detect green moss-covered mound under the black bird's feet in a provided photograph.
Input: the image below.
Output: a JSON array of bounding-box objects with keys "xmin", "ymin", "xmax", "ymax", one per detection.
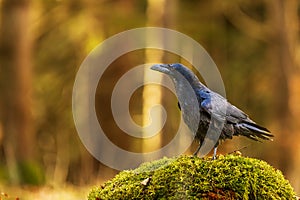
[{"xmin": 88, "ymin": 155, "xmax": 296, "ymax": 200}]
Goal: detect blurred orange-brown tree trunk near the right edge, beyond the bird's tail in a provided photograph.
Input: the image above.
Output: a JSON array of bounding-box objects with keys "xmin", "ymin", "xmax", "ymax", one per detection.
[{"xmin": 266, "ymin": 0, "xmax": 300, "ymax": 191}]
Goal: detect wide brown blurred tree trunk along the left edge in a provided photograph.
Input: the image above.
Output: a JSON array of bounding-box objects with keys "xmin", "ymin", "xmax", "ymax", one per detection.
[{"xmin": 0, "ymin": 0, "xmax": 42, "ymax": 183}]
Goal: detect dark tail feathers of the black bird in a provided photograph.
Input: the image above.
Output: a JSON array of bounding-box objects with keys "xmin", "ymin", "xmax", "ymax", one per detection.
[{"xmin": 238, "ymin": 121, "xmax": 274, "ymax": 141}]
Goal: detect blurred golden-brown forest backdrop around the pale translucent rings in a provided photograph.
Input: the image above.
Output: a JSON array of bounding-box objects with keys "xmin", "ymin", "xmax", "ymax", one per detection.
[{"xmin": 0, "ymin": 0, "xmax": 300, "ymax": 198}]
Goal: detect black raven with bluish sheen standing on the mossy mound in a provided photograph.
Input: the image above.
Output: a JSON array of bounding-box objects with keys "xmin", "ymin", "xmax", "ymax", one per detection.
[{"xmin": 151, "ymin": 63, "xmax": 273, "ymax": 159}]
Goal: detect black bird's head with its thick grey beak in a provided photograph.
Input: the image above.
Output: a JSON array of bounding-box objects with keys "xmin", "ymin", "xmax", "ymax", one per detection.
[{"xmin": 151, "ymin": 63, "xmax": 200, "ymax": 85}]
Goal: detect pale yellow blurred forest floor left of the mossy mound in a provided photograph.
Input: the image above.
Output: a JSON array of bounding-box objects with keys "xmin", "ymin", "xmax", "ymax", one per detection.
[{"xmin": 0, "ymin": 184, "xmax": 93, "ymax": 200}]
